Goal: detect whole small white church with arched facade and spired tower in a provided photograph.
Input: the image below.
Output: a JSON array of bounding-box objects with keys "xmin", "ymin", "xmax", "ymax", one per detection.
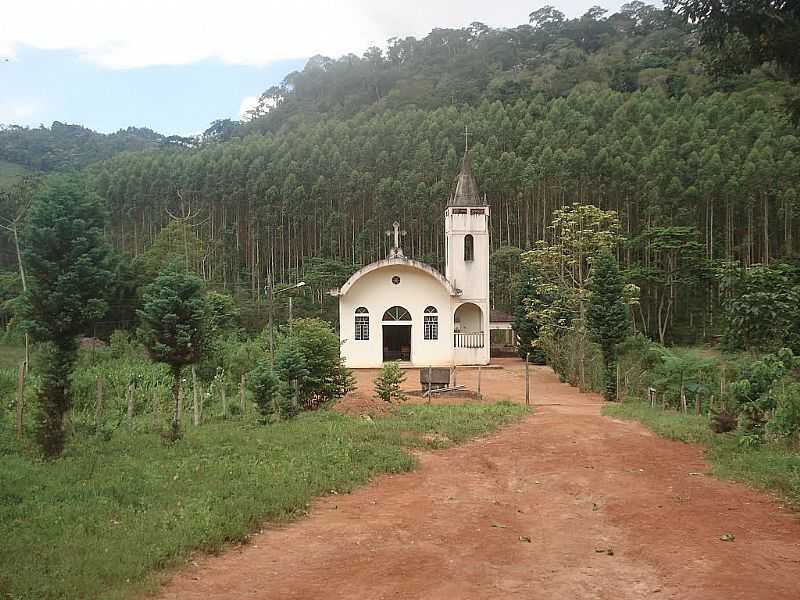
[{"xmin": 331, "ymin": 150, "xmax": 511, "ymax": 368}]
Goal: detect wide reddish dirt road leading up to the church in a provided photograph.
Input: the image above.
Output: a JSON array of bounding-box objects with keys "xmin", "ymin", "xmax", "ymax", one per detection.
[{"xmin": 153, "ymin": 360, "xmax": 800, "ymax": 600}]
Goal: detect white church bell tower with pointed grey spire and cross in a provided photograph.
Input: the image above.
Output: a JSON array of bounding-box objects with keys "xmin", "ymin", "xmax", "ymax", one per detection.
[{"xmin": 444, "ymin": 131, "xmax": 489, "ymax": 310}]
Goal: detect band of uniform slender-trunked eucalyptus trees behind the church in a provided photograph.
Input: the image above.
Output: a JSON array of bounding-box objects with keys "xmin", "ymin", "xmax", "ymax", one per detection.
[{"xmin": 79, "ymin": 91, "xmax": 800, "ymax": 339}]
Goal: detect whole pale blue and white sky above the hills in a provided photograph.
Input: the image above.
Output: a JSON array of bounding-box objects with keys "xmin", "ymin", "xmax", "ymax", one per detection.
[{"xmin": 0, "ymin": 0, "xmax": 632, "ymax": 135}]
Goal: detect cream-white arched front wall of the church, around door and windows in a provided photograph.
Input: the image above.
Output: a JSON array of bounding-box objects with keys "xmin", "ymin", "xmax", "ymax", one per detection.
[{"xmin": 339, "ymin": 265, "xmax": 456, "ymax": 368}]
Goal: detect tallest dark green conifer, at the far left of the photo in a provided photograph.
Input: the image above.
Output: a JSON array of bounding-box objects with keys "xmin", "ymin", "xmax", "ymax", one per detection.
[{"xmin": 20, "ymin": 178, "xmax": 111, "ymax": 456}]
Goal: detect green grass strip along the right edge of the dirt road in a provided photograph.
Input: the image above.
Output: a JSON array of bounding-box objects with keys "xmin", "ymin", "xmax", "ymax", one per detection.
[{"xmin": 603, "ymin": 402, "xmax": 800, "ymax": 506}]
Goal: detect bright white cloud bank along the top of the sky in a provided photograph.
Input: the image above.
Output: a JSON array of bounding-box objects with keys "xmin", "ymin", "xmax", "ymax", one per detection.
[{"xmin": 0, "ymin": 0, "xmax": 619, "ymax": 68}]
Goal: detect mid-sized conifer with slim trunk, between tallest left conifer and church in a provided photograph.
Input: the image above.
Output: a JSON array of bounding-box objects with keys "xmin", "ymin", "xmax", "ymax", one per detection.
[{"xmin": 136, "ymin": 264, "xmax": 206, "ymax": 440}]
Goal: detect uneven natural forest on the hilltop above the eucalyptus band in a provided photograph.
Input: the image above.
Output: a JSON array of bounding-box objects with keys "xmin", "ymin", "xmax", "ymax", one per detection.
[{"xmin": 242, "ymin": 1, "xmax": 758, "ymax": 124}]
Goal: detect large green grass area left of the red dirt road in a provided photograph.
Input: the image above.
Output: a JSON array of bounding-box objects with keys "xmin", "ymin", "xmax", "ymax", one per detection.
[{"xmin": 0, "ymin": 403, "xmax": 526, "ymax": 600}]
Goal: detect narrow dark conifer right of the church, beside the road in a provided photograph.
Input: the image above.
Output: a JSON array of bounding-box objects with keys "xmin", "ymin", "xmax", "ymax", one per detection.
[{"xmin": 586, "ymin": 251, "xmax": 630, "ymax": 400}]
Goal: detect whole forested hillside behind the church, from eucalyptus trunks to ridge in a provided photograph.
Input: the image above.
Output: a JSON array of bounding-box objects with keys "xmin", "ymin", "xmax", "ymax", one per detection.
[{"xmin": 0, "ymin": 2, "xmax": 800, "ymax": 339}]
